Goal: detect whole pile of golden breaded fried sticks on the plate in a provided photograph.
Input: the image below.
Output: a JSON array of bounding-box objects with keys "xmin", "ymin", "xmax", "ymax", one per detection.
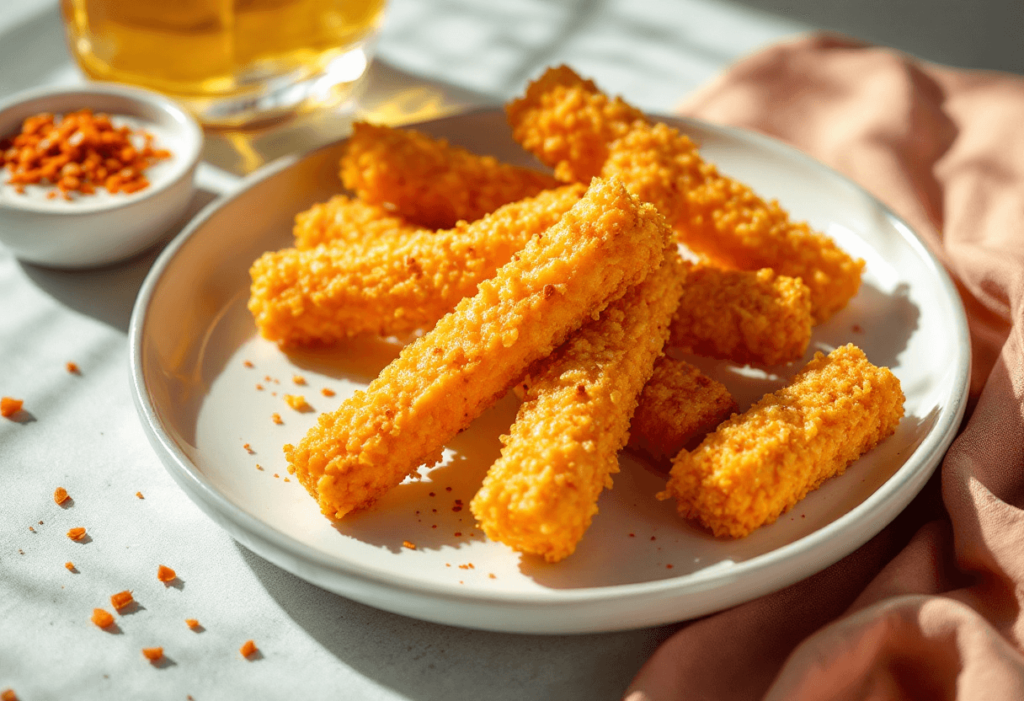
[{"xmin": 249, "ymin": 67, "xmax": 903, "ymax": 562}]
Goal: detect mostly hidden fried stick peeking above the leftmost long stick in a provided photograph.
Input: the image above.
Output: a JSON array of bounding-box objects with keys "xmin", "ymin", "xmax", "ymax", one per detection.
[{"xmin": 292, "ymin": 194, "xmax": 424, "ymax": 249}]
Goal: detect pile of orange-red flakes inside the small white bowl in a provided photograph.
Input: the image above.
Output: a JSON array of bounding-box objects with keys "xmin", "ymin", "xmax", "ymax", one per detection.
[{"xmin": 0, "ymin": 108, "xmax": 171, "ymax": 200}]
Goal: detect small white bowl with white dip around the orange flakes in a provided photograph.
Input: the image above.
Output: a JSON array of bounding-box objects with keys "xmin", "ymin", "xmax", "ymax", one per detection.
[{"xmin": 0, "ymin": 84, "xmax": 203, "ymax": 268}]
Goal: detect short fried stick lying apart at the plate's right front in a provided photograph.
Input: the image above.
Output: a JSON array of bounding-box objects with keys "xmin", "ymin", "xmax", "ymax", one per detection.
[{"xmin": 658, "ymin": 344, "xmax": 903, "ymax": 538}]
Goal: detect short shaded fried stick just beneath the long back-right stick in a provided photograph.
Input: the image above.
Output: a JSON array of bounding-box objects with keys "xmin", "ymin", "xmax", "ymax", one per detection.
[{"xmin": 670, "ymin": 263, "xmax": 811, "ymax": 364}]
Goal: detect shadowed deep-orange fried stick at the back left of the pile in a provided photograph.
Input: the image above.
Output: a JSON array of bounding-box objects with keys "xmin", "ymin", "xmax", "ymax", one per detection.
[{"xmin": 341, "ymin": 123, "xmax": 558, "ymax": 229}]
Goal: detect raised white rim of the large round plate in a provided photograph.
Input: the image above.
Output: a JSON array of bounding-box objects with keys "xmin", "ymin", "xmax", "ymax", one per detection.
[{"xmin": 128, "ymin": 107, "xmax": 972, "ymax": 632}]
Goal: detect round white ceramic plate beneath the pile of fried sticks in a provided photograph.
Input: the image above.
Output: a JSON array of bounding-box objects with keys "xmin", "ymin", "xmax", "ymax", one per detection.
[{"xmin": 130, "ymin": 109, "xmax": 970, "ymax": 633}]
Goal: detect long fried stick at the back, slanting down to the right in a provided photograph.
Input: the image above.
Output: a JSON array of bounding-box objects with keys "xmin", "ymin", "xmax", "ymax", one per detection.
[{"xmin": 507, "ymin": 67, "xmax": 864, "ymax": 322}]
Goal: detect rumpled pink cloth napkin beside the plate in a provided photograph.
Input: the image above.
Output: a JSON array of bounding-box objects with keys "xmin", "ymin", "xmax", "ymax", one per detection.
[{"xmin": 627, "ymin": 36, "xmax": 1024, "ymax": 701}]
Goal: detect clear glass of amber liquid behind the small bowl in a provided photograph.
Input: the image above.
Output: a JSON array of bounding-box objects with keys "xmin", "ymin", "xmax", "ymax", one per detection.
[{"xmin": 61, "ymin": 0, "xmax": 385, "ymax": 123}]
